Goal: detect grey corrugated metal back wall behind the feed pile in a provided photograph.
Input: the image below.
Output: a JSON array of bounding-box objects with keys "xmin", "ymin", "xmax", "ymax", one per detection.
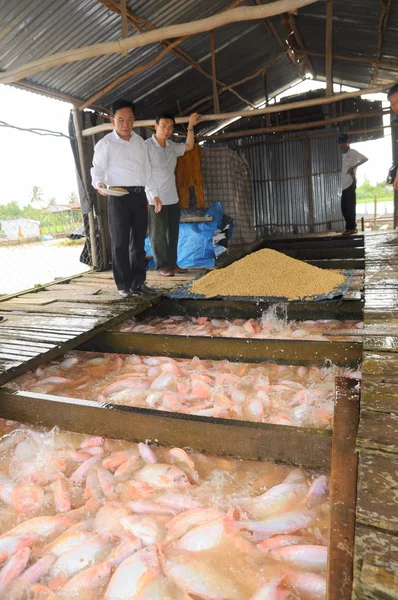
[{"xmin": 213, "ymin": 130, "xmax": 343, "ymax": 235}]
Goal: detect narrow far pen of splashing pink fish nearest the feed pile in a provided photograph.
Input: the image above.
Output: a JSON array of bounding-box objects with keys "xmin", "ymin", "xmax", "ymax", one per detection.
[{"xmin": 118, "ymin": 316, "xmax": 363, "ymax": 341}]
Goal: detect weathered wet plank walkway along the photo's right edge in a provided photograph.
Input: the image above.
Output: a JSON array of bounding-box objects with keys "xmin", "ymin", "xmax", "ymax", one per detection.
[{"xmin": 353, "ymin": 232, "xmax": 398, "ymax": 600}]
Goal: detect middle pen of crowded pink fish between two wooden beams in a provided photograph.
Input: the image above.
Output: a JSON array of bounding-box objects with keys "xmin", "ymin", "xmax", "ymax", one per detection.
[{"xmin": 6, "ymin": 352, "xmax": 360, "ymax": 428}]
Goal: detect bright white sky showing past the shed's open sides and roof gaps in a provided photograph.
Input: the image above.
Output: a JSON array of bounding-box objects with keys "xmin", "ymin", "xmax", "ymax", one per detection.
[{"xmin": 0, "ymin": 80, "xmax": 391, "ymax": 207}]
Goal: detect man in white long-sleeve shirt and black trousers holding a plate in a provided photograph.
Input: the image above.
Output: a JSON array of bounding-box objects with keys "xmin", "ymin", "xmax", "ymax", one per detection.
[{"xmin": 91, "ymin": 100, "xmax": 162, "ymax": 298}]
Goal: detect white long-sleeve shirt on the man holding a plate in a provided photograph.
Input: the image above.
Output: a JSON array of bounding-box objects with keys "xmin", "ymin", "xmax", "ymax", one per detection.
[{"xmin": 91, "ymin": 130, "xmax": 158, "ymax": 198}]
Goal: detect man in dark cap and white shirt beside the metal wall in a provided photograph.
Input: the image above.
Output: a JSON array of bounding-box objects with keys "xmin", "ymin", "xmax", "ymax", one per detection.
[{"xmin": 338, "ymin": 133, "xmax": 368, "ymax": 235}]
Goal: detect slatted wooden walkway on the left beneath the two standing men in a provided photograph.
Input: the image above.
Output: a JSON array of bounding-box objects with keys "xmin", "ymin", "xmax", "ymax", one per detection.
[{"xmin": 0, "ymin": 269, "xmax": 203, "ymax": 385}]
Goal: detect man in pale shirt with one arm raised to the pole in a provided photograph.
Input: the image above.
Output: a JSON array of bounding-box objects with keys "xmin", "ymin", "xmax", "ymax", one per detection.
[{"xmin": 145, "ymin": 113, "xmax": 200, "ymax": 277}]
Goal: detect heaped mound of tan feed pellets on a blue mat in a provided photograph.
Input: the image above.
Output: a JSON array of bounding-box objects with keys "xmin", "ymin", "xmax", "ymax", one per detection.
[{"xmin": 191, "ymin": 249, "xmax": 346, "ymax": 300}]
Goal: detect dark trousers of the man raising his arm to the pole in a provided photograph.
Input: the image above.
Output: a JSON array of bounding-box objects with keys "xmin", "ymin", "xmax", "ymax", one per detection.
[{"xmin": 149, "ymin": 203, "xmax": 181, "ymax": 271}]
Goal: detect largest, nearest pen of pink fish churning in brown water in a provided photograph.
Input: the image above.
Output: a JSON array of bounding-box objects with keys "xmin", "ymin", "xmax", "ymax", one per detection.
[{"xmin": 0, "ymin": 420, "xmax": 329, "ymax": 600}]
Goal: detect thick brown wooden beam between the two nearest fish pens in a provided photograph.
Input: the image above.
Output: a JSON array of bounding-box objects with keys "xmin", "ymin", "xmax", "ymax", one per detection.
[{"xmin": 0, "ymin": 388, "xmax": 332, "ymax": 469}]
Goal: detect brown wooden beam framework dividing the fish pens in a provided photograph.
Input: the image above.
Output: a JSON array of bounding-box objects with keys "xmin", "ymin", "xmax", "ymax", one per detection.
[{"xmin": 0, "ymin": 284, "xmax": 362, "ymax": 600}]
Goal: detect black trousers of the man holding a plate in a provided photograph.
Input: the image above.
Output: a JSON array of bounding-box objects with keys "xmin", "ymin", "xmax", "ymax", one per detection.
[{"xmin": 108, "ymin": 187, "xmax": 148, "ymax": 290}]
